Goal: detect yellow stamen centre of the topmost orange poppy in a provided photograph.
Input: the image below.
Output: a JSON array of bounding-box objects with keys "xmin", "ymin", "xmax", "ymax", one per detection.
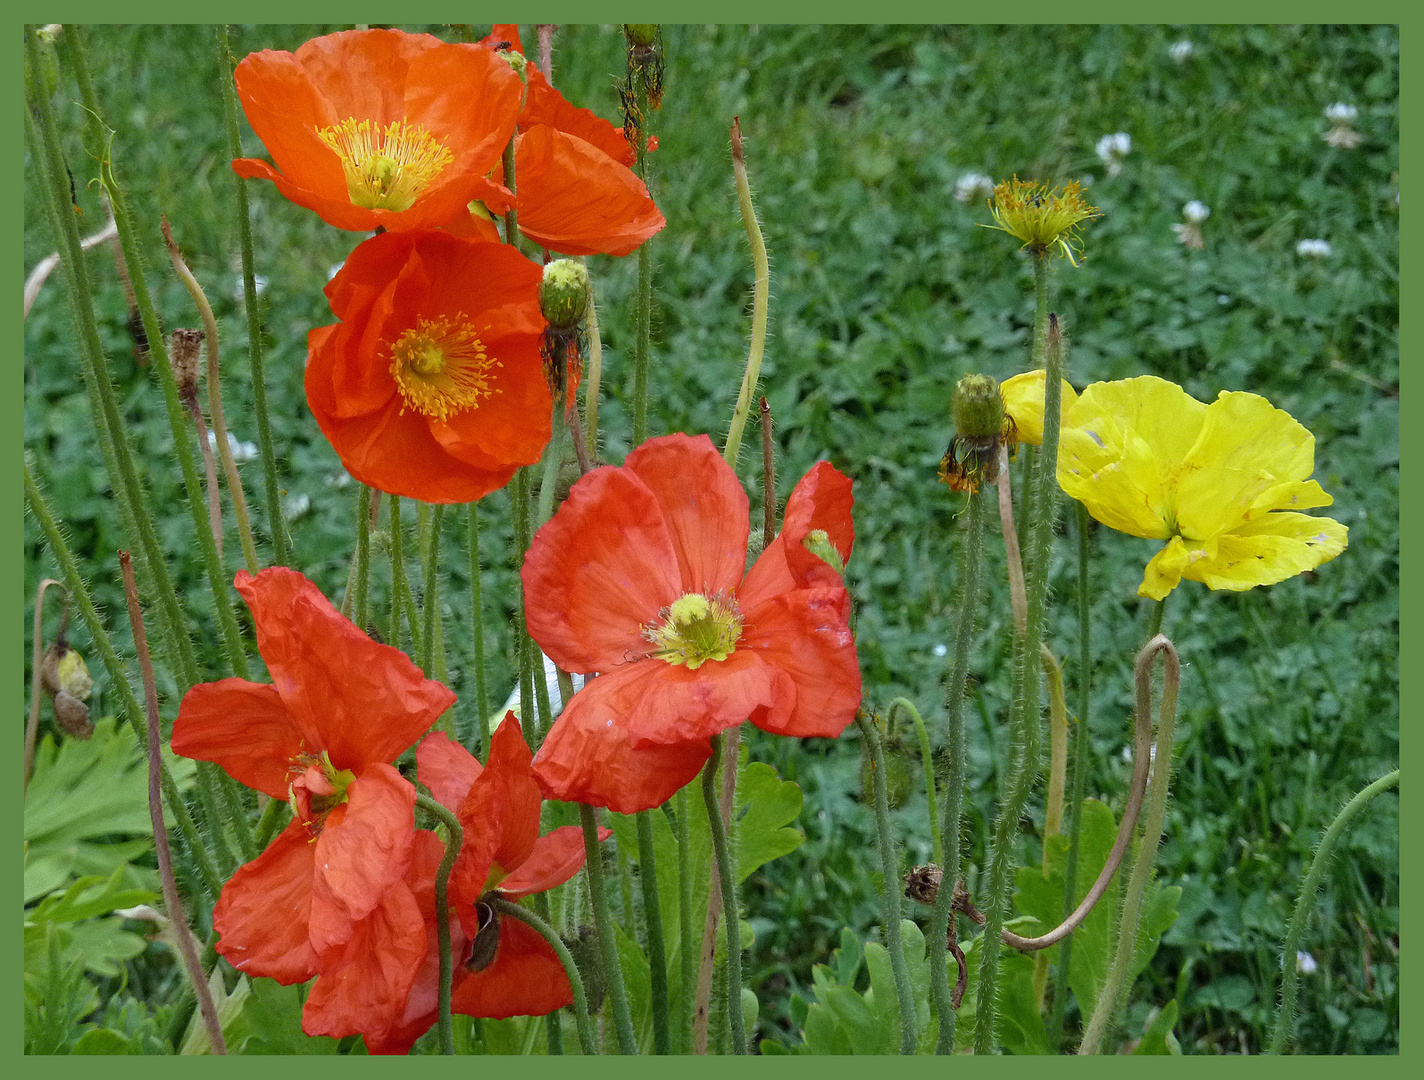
[{"xmin": 316, "ymin": 117, "xmax": 454, "ymax": 211}]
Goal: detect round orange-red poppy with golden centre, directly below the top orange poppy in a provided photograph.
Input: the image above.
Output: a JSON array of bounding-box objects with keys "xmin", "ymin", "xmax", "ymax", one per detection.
[{"xmin": 306, "ymin": 232, "xmax": 553, "ymax": 503}]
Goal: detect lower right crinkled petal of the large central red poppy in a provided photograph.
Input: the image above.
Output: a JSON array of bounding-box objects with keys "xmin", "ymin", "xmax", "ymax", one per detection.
[{"xmin": 738, "ymin": 587, "xmax": 860, "ymax": 738}]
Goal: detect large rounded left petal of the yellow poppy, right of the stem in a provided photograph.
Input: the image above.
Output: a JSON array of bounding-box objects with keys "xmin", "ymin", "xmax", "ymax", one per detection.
[{"xmin": 1058, "ymin": 375, "xmax": 1206, "ymax": 540}]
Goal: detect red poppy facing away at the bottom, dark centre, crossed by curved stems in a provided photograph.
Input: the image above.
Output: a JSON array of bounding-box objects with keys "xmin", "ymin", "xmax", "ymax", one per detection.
[{"xmin": 362, "ymin": 714, "xmax": 612, "ymax": 1053}]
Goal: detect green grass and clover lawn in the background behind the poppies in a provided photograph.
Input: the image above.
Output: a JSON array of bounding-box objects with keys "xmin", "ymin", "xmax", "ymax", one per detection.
[{"xmin": 24, "ymin": 26, "xmax": 1398, "ymax": 1053}]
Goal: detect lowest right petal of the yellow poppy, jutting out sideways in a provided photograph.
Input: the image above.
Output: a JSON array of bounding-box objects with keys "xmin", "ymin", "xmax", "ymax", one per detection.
[{"xmin": 1182, "ymin": 513, "xmax": 1349, "ymax": 593}]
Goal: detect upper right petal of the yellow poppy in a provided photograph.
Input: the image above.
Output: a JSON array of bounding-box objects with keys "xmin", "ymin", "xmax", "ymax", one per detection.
[{"xmin": 1176, "ymin": 392, "xmax": 1329, "ymax": 536}]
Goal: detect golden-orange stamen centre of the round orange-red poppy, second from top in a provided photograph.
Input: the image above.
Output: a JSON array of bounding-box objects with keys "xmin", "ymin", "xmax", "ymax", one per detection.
[{"xmin": 390, "ymin": 315, "xmax": 501, "ymax": 423}]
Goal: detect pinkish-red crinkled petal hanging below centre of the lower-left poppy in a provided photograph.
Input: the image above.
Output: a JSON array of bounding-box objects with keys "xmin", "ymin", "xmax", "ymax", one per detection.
[{"xmin": 310, "ymin": 765, "xmax": 416, "ymax": 955}]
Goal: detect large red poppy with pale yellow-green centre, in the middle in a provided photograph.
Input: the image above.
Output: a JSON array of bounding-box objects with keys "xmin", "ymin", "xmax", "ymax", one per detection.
[{"xmin": 523, "ymin": 435, "xmax": 860, "ymax": 814}]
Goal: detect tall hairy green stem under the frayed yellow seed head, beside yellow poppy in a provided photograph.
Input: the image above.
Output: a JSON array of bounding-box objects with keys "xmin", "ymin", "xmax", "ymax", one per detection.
[{"xmin": 974, "ymin": 255, "xmax": 1064, "ymax": 1054}]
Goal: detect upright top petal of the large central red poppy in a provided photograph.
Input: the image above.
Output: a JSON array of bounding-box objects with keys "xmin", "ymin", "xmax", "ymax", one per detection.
[{"xmin": 624, "ymin": 435, "xmax": 749, "ymax": 596}]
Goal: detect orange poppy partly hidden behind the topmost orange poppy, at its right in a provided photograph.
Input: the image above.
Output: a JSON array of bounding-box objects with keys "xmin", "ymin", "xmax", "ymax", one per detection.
[{"xmin": 457, "ymin": 24, "xmax": 668, "ymax": 255}]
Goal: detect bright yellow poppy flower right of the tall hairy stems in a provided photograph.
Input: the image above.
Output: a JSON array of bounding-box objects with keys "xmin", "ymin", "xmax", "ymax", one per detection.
[{"xmin": 1059, "ymin": 375, "xmax": 1349, "ymax": 600}]
